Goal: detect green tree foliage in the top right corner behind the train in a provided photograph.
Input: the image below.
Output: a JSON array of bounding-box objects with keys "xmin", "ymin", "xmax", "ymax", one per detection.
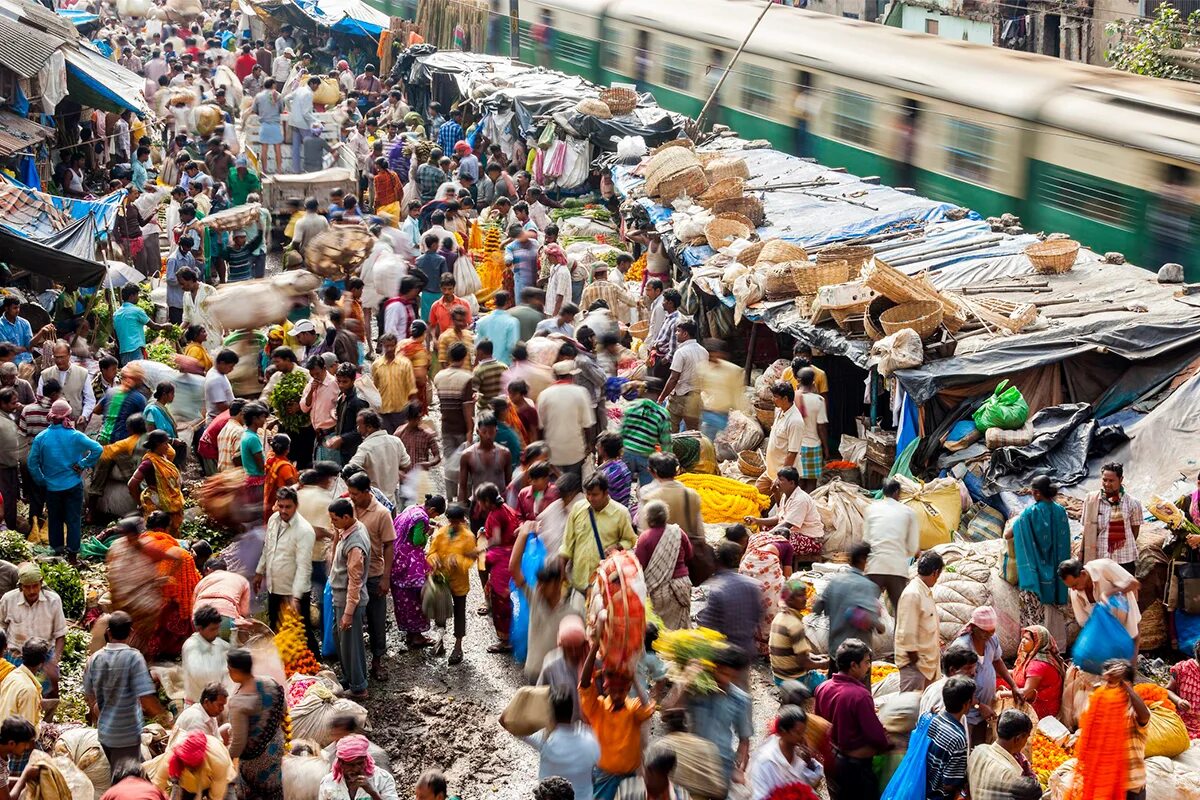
[{"xmin": 1104, "ymin": 2, "xmax": 1200, "ymax": 80}]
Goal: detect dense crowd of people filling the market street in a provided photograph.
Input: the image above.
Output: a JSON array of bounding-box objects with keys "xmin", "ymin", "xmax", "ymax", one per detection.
[{"xmin": 0, "ymin": 1, "xmax": 1200, "ymax": 800}]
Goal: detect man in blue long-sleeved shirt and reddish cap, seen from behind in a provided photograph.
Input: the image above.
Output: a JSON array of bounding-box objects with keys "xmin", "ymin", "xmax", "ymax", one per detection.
[{"xmin": 28, "ymin": 399, "xmax": 103, "ymax": 559}]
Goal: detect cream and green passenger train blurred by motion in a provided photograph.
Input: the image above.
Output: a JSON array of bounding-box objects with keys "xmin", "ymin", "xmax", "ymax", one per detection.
[{"xmin": 367, "ymin": 0, "xmax": 1200, "ymax": 281}]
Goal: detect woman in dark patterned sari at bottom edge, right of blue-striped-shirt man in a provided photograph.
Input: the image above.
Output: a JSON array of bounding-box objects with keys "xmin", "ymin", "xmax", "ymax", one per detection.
[{"xmin": 227, "ymin": 648, "xmax": 288, "ymax": 800}]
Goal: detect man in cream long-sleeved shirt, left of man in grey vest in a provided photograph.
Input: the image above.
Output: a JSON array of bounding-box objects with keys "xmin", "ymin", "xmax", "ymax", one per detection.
[{"xmin": 253, "ymin": 486, "xmax": 317, "ymax": 631}]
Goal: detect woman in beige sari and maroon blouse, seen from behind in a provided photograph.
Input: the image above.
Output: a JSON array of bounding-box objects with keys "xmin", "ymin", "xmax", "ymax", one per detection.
[{"xmin": 634, "ymin": 500, "xmax": 691, "ymax": 630}]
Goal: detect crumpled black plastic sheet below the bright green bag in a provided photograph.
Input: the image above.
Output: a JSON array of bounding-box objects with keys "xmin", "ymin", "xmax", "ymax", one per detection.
[{"xmin": 984, "ymin": 403, "xmax": 1127, "ymax": 494}]
